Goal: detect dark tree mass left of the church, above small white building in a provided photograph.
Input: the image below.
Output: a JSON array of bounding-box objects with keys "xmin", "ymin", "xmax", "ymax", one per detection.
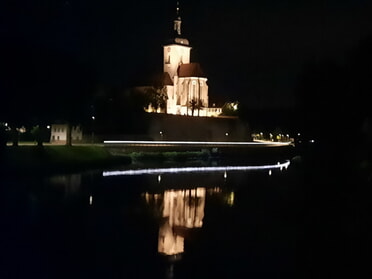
[{"xmin": 0, "ymin": 41, "xmax": 155, "ymax": 142}]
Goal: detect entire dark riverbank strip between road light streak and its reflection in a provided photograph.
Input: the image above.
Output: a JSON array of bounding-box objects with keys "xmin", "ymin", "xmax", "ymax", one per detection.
[{"xmin": 0, "ymin": 145, "xmax": 293, "ymax": 174}]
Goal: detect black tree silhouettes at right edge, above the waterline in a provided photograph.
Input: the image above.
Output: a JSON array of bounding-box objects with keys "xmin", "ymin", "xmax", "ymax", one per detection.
[{"xmin": 296, "ymin": 37, "xmax": 372, "ymax": 165}]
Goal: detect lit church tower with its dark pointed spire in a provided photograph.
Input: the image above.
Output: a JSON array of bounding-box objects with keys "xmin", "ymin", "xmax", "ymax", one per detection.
[{"xmin": 163, "ymin": 2, "xmax": 191, "ymax": 82}]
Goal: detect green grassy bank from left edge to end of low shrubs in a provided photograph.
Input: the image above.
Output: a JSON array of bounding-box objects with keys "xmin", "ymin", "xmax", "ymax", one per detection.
[{"xmin": 0, "ymin": 145, "xmax": 214, "ymax": 172}]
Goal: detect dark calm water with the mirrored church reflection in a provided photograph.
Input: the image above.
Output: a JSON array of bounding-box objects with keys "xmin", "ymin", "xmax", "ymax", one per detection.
[{"xmin": 0, "ymin": 159, "xmax": 362, "ymax": 278}]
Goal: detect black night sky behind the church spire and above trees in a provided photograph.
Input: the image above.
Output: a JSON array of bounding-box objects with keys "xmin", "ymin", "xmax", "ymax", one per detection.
[{"xmin": 0, "ymin": 0, "xmax": 372, "ymax": 112}]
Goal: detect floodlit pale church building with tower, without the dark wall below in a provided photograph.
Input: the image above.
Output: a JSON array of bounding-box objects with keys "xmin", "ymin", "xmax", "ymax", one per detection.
[{"xmin": 147, "ymin": 2, "xmax": 222, "ymax": 117}]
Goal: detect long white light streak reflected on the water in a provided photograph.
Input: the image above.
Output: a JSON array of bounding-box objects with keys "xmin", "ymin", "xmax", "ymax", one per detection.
[{"xmin": 102, "ymin": 161, "xmax": 290, "ymax": 176}]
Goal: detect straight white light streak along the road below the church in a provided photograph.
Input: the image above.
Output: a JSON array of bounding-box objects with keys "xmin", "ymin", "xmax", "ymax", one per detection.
[{"xmin": 103, "ymin": 140, "xmax": 292, "ymax": 146}]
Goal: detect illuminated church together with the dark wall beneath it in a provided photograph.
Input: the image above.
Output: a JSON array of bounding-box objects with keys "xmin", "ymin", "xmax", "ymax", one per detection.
[{"xmin": 137, "ymin": 3, "xmax": 251, "ymax": 141}]
